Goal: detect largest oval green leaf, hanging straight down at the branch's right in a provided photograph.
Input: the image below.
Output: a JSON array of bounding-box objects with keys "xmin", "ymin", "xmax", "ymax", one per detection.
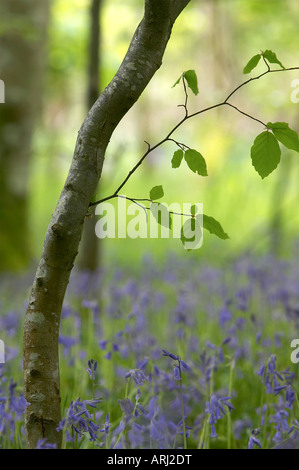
[{"xmin": 251, "ymin": 131, "xmax": 281, "ymax": 178}]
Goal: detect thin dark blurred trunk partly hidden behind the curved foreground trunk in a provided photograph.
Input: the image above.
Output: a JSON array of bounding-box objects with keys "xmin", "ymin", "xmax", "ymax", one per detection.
[{"xmin": 79, "ymin": 0, "xmax": 103, "ymax": 271}]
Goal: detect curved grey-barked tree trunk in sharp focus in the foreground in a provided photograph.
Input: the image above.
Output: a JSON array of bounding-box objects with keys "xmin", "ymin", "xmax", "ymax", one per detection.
[{"xmin": 24, "ymin": 0, "xmax": 190, "ymax": 448}]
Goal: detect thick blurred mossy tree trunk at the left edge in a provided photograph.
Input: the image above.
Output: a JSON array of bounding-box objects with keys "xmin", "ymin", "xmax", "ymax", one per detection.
[{"xmin": 0, "ymin": 0, "xmax": 49, "ymax": 270}]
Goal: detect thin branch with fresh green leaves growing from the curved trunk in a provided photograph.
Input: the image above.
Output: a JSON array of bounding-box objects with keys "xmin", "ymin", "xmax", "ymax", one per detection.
[{"xmin": 90, "ymin": 49, "xmax": 299, "ymax": 248}]
